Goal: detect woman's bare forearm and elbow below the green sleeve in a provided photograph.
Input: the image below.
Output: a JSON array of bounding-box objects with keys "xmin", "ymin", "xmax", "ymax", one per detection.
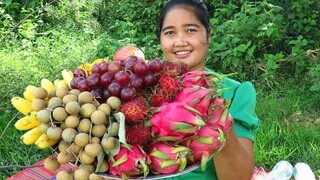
[{"xmin": 214, "ymin": 127, "xmax": 255, "ymax": 180}]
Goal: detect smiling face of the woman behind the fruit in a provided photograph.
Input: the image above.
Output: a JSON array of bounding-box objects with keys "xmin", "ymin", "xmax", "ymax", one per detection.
[{"xmin": 160, "ymin": 7, "xmax": 210, "ymax": 71}]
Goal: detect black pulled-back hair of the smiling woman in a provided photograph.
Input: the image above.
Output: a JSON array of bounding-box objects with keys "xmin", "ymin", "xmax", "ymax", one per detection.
[{"xmin": 156, "ymin": 0, "xmax": 211, "ymax": 38}]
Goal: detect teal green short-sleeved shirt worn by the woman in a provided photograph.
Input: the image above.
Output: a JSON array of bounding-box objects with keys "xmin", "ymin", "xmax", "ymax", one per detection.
[{"xmin": 162, "ymin": 69, "xmax": 260, "ymax": 180}]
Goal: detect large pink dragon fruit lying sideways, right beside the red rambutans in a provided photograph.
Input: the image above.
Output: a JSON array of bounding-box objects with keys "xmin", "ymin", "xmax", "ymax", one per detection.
[{"xmin": 150, "ymin": 102, "xmax": 205, "ymax": 141}]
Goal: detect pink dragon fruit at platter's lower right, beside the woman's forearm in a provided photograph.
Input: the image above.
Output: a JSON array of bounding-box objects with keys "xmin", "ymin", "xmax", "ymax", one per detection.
[{"xmin": 181, "ymin": 125, "xmax": 225, "ymax": 170}]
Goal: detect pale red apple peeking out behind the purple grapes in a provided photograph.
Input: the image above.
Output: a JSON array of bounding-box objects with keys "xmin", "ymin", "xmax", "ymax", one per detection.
[{"xmin": 113, "ymin": 45, "xmax": 145, "ymax": 61}]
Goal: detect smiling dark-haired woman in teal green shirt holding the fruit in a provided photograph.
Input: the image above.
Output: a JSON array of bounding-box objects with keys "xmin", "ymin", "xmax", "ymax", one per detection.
[{"xmin": 158, "ymin": 0, "xmax": 259, "ymax": 179}]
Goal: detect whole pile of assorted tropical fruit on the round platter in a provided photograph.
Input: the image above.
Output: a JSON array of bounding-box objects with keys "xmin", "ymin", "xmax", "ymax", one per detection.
[{"xmin": 11, "ymin": 45, "xmax": 232, "ymax": 179}]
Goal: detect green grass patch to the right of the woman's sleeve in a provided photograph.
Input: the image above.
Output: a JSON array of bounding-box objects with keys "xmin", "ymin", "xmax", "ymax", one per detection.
[{"xmin": 255, "ymin": 82, "xmax": 320, "ymax": 175}]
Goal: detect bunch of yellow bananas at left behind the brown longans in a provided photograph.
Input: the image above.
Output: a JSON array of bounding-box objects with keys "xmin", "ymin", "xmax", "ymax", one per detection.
[{"xmin": 11, "ymin": 69, "xmax": 73, "ymax": 149}]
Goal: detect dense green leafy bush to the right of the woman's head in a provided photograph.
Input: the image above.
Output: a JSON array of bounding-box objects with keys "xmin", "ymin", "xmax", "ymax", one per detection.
[{"xmin": 207, "ymin": 1, "xmax": 320, "ymax": 88}]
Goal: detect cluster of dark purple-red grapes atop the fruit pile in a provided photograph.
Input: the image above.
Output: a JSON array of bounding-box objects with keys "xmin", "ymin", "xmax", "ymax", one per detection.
[{"xmin": 70, "ymin": 56, "xmax": 163, "ymax": 101}]
